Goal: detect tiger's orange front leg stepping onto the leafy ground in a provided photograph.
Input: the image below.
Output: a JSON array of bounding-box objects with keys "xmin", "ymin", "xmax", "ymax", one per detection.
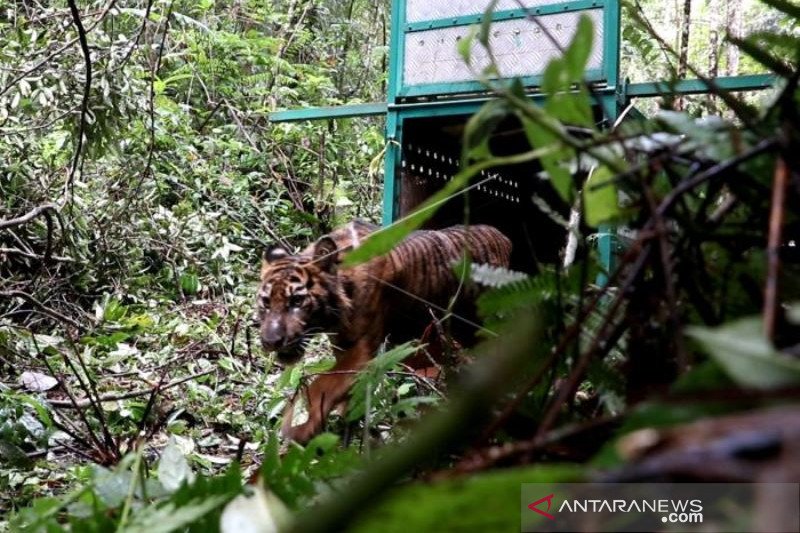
[{"xmin": 281, "ymin": 339, "xmax": 379, "ymax": 443}]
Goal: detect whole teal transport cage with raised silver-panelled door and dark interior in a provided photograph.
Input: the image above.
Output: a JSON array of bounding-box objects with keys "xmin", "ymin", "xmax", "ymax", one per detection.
[{"xmin": 270, "ymin": 0, "xmax": 774, "ymax": 283}]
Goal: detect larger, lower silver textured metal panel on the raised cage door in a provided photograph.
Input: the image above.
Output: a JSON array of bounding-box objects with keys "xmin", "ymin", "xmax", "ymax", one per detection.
[{"xmin": 403, "ymin": 9, "xmax": 603, "ymax": 86}]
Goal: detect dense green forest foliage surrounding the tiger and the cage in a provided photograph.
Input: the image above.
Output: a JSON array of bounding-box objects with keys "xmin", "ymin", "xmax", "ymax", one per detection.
[{"xmin": 0, "ymin": 0, "xmax": 800, "ymax": 531}]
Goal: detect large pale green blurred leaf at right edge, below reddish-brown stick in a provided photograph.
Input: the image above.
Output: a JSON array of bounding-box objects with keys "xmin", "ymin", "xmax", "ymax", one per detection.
[{"xmin": 686, "ymin": 317, "xmax": 800, "ymax": 390}]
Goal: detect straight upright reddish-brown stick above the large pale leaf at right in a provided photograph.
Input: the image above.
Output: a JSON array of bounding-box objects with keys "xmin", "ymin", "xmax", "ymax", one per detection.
[{"xmin": 764, "ymin": 157, "xmax": 789, "ymax": 339}]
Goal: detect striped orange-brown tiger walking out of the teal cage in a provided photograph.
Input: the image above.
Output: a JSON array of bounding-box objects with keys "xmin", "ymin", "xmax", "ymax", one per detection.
[{"xmin": 257, "ymin": 222, "xmax": 511, "ymax": 442}]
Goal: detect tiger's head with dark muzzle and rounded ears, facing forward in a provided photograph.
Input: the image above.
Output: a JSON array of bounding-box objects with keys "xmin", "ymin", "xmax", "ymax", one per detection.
[{"xmin": 256, "ymin": 237, "xmax": 342, "ymax": 364}]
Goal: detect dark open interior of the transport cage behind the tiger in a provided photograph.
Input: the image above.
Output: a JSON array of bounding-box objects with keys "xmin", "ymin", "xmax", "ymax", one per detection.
[{"xmin": 400, "ymin": 111, "xmax": 608, "ymax": 273}]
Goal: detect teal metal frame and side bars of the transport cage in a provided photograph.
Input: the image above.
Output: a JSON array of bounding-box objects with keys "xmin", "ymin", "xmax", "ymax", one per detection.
[{"xmin": 269, "ymin": 0, "xmax": 775, "ymax": 284}]
